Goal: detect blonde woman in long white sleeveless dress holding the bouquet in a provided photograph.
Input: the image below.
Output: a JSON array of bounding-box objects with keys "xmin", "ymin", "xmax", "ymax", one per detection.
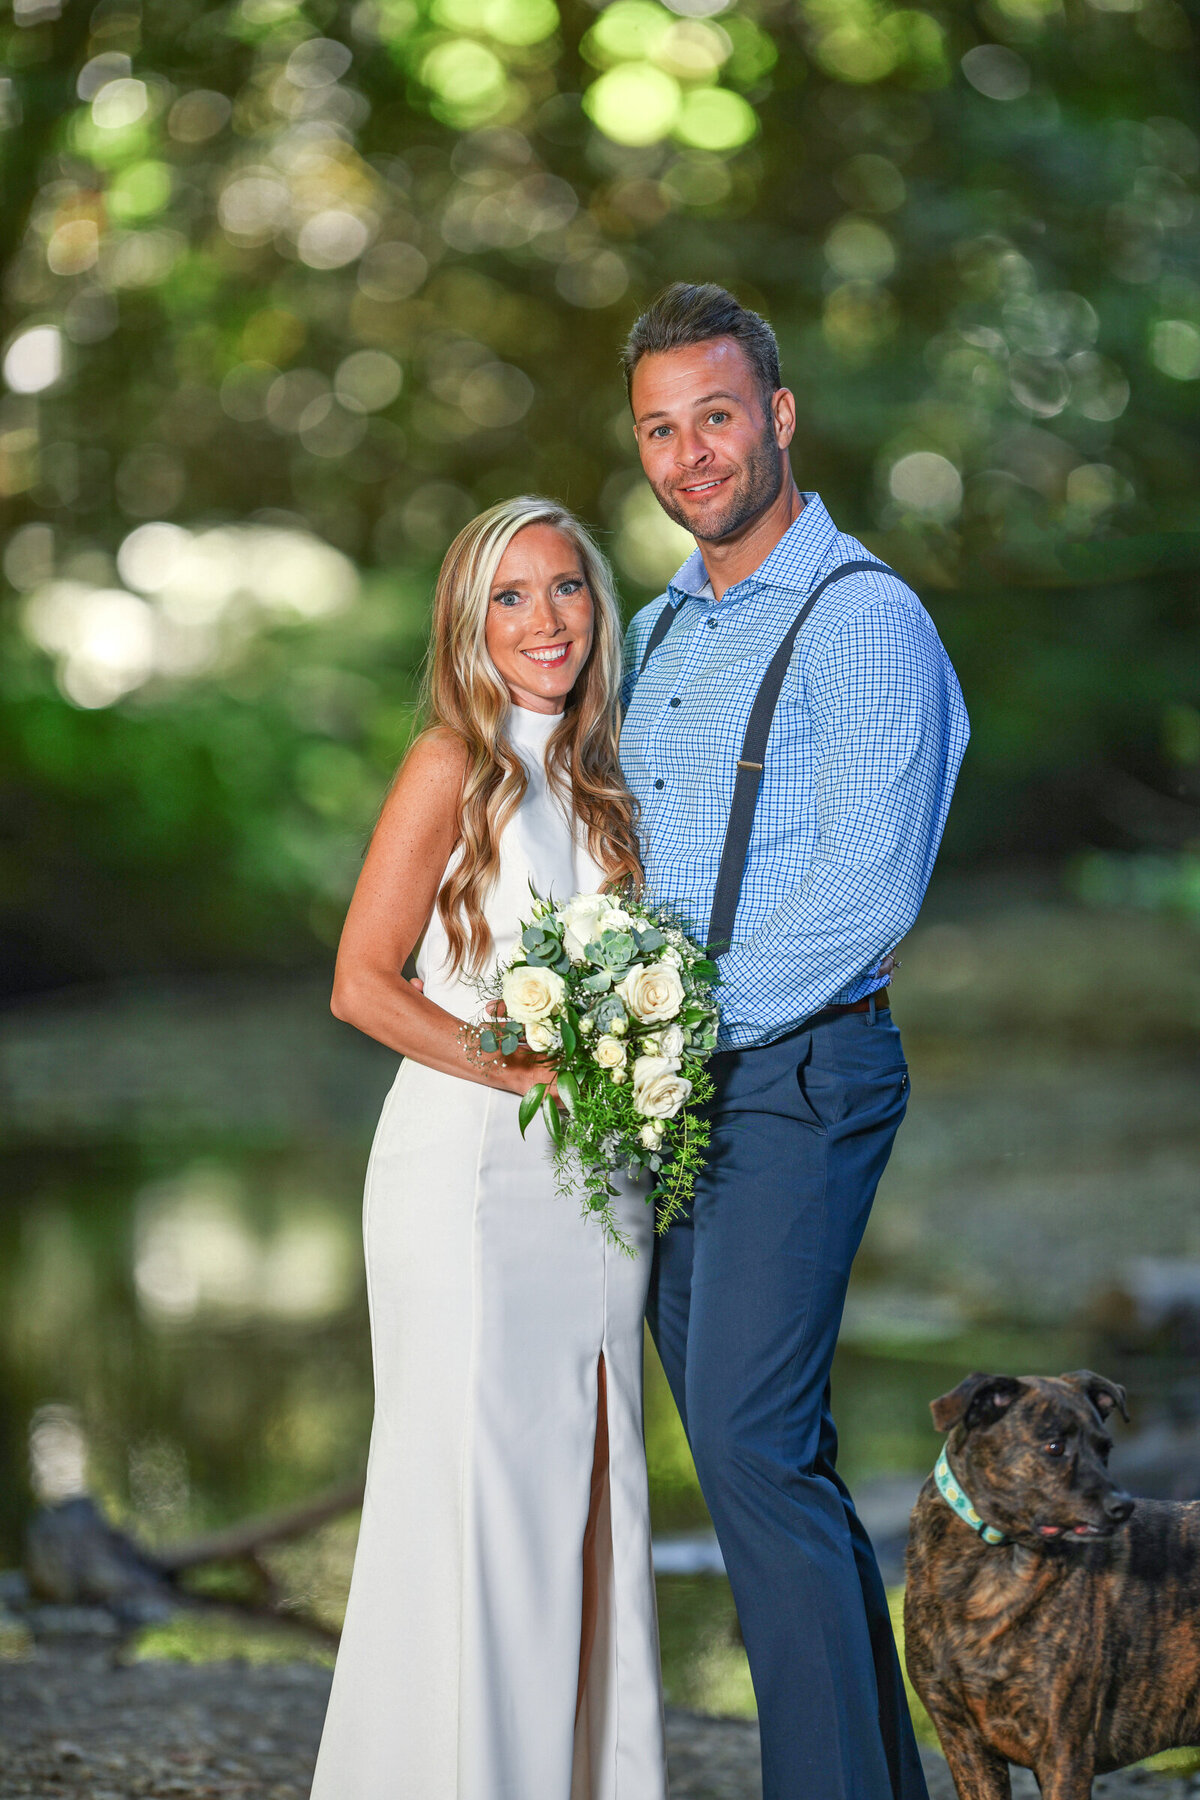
[{"xmin": 313, "ymin": 497, "xmax": 666, "ymax": 1800}]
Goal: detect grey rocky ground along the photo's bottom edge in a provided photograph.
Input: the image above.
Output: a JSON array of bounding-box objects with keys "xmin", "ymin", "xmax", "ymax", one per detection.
[{"xmin": 0, "ymin": 1645, "xmax": 1200, "ymax": 1800}]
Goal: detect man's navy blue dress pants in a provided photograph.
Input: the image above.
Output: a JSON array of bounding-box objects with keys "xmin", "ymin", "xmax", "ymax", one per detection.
[{"xmin": 648, "ymin": 1010, "xmax": 927, "ymax": 1800}]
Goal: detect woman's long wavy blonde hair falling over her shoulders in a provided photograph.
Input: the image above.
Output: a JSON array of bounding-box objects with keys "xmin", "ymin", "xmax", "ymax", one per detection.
[{"xmin": 425, "ymin": 493, "xmax": 642, "ymax": 972}]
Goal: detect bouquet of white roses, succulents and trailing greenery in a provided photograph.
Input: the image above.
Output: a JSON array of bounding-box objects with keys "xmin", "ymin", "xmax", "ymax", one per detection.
[{"xmin": 479, "ymin": 895, "xmax": 718, "ymax": 1244}]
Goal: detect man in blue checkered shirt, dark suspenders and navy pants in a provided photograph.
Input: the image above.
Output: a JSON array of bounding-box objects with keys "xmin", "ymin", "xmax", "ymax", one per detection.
[{"xmin": 621, "ymin": 283, "xmax": 968, "ymax": 1800}]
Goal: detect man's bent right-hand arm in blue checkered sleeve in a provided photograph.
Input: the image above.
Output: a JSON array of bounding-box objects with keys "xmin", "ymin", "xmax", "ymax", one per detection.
[{"xmin": 718, "ymin": 603, "xmax": 968, "ymax": 1037}]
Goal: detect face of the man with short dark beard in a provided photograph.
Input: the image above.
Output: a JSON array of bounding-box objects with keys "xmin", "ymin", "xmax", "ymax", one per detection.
[{"xmin": 630, "ymin": 337, "xmax": 795, "ymax": 544}]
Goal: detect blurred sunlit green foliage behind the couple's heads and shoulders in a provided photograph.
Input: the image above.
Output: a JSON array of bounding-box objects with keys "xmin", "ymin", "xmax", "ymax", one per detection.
[{"xmin": 0, "ymin": 0, "xmax": 1200, "ymax": 985}]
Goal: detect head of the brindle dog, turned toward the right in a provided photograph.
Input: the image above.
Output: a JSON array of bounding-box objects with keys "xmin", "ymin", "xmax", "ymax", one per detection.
[{"xmin": 930, "ymin": 1368, "xmax": 1133, "ymax": 1550}]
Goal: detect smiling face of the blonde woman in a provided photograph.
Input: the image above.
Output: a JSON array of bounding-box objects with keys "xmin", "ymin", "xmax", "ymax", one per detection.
[{"xmin": 486, "ymin": 524, "xmax": 594, "ymax": 713}]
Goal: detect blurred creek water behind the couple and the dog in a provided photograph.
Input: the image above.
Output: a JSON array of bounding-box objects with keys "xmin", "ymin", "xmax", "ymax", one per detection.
[{"xmin": 0, "ymin": 913, "xmax": 1200, "ymax": 1714}]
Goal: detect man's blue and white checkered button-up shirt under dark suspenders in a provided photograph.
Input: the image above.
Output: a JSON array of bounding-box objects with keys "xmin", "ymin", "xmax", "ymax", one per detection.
[{"xmin": 621, "ymin": 493, "xmax": 970, "ymax": 1049}]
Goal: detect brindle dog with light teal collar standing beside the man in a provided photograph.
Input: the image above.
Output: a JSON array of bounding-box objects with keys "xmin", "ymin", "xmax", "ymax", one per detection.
[{"xmin": 905, "ymin": 1370, "xmax": 1200, "ymax": 1800}]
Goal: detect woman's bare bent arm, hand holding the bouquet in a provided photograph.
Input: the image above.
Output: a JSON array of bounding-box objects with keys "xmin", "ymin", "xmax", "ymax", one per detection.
[{"xmin": 329, "ymin": 731, "xmax": 552, "ymax": 1094}]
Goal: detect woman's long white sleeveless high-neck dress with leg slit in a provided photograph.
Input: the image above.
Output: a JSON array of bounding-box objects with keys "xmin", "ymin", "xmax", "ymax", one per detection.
[{"xmin": 313, "ymin": 707, "xmax": 667, "ymax": 1800}]
